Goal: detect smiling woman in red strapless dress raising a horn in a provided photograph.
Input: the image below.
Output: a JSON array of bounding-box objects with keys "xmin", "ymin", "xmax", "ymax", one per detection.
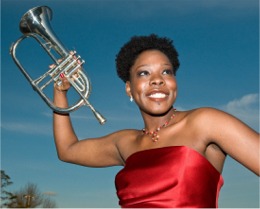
[{"xmin": 54, "ymin": 34, "xmax": 259, "ymax": 208}]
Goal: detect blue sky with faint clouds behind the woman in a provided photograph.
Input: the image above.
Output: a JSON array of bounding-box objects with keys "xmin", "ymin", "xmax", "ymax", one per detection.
[{"xmin": 1, "ymin": 0, "xmax": 259, "ymax": 208}]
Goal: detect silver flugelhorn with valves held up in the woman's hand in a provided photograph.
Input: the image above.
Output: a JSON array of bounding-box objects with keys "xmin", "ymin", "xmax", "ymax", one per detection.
[{"xmin": 10, "ymin": 6, "xmax": 106, "ymax": 124}]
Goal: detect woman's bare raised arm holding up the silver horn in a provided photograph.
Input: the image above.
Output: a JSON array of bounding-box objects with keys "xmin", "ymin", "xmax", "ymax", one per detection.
[{"xmin": 53, "ymin": 81, "xmax": 122, "ymax": 167}]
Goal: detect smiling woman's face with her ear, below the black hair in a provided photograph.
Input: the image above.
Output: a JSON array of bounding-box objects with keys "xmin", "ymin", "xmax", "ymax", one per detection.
[{"xmin": 126, "ymin": 50, "xmax": 177, "ymax": 114}]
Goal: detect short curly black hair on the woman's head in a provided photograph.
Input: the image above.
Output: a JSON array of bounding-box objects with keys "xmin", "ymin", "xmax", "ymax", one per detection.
[{"xmin": 116, "ymin": 34, "xmax": 180, "ymax": 82}]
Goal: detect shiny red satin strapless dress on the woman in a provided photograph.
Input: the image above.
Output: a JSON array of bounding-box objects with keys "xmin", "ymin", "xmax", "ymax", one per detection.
[{"xmin": 115, "ymin": 146, "xmax": 224, "ymax": 208}]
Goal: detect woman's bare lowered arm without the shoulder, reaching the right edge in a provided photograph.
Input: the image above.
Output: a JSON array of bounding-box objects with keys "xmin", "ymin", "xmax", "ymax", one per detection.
[{"xmin": 198, "ymin": 108, "xmax": 260, "ymax": 176}]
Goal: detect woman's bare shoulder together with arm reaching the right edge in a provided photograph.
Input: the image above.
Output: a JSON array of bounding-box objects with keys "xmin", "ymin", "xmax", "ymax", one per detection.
[{"xmin": 176, "ymin": 107, "xmax": 260, "ymax": 175}]
